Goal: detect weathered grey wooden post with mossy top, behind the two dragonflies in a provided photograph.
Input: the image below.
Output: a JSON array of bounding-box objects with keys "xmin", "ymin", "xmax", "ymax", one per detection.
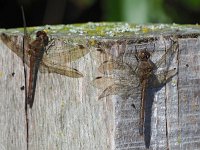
[{"xmin": 0, "ymin": 23, "xmax": 200, "ymax": 150}]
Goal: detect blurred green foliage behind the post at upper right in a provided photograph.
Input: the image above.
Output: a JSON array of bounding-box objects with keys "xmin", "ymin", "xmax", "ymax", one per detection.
[{"xmin": 103, "ymin": 0, "xmax": 200, "ymax": 24}]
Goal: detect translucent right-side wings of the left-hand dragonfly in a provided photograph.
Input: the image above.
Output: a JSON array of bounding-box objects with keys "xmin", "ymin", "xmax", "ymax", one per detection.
[{"xmin": 41, "ymin": 44, "xmax": 89, "ymax": 78}]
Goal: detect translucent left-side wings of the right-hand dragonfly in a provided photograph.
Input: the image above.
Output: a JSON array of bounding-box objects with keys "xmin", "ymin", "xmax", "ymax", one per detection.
[{"xmin": 92, "ymin": 60, "xmax": 139, "ymax": 99}]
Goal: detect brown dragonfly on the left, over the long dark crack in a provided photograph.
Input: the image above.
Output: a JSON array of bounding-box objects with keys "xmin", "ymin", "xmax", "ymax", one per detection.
[{"xmin": 0, "ymin": 31, "xmax": 89, "ymax": 108}]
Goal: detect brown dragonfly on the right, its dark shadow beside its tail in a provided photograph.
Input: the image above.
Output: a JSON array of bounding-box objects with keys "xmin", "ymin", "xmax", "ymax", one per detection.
[{"xmin": 92, "ymin": 41, "xmax": 178, "ymax": 135}]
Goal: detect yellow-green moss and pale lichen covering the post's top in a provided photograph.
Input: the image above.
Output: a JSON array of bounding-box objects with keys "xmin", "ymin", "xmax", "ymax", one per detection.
[{"xmin": 1, "ymin": 22, "xmax": 200, "ymax": 38}]
